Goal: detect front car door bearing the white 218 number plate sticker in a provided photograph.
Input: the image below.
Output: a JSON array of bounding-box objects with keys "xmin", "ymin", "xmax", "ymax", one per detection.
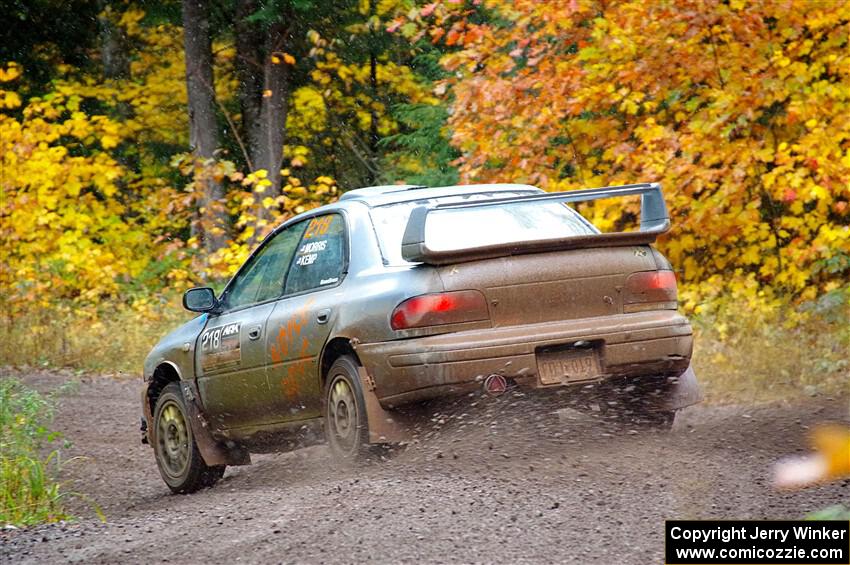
[{"xmin": 195, "ymin": 223, "xmax": 304, "ymax": 428}]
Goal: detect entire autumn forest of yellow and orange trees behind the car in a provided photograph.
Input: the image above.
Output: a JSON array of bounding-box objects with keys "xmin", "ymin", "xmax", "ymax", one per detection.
[{"xmin": 0, "ymin": 0, "xmax": 850, "ymax": 384}]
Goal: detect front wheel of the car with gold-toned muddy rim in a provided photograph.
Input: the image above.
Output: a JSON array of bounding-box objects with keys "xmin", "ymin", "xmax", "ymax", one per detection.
[{"xmin": 153, "ymin": 383, "xmax": 225, "ymax": 494}]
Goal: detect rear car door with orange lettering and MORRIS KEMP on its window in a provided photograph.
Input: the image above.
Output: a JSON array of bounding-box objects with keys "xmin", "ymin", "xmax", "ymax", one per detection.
[{"xmin": 266, "ymin": 214, "xmax": 348, "ymax": 421}]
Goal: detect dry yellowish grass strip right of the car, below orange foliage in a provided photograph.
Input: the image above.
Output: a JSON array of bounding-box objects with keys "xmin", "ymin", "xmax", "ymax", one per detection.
[{"xmin": 691, "ymin": 290, "xmax": 850, "ymax": 403}]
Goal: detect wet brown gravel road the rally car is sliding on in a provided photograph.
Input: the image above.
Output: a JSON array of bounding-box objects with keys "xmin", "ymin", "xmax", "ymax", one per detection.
[{"xmin": 0, "ymin": 371, "xmax": 850, "ymax": 564}]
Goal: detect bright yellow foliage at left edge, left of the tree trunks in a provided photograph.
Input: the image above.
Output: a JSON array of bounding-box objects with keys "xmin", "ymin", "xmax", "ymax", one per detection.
[{"xmin": 0, "ymin": 68, "xmax": 182, "ymax": 305}]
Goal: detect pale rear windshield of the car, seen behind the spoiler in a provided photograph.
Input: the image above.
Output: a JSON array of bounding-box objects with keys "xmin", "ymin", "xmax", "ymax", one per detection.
[{"xmin": 371, "ymin": 192, "xmax": 598, "ymax": 265}]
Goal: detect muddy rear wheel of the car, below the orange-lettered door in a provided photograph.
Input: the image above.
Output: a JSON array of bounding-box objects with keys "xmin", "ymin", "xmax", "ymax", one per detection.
[{"xmin": 324, "ymin": 355, "xmax": 371, "ymax": 462}]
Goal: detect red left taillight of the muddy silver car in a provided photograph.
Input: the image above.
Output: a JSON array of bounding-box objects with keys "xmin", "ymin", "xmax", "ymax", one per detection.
[{"xmin": 390, "ymin": 290, "xmax": 489, "ymax": 330}]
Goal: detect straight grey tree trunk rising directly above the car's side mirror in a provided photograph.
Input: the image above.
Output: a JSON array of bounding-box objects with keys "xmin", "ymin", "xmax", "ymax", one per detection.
[{"xmin": 183, "ymin": 0, "xmax": 226, "ymax": 252}]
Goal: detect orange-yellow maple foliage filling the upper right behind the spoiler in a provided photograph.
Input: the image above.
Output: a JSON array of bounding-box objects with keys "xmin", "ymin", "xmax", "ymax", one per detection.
[{"xmin": 396, "ymin": 0, "xmax": 850, "ymax": 304}]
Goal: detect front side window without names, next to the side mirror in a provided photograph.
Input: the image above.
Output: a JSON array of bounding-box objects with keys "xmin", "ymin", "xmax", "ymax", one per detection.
[{"xmin": 225, "ymin": 222, "xmax": 306, "ymax": 309}]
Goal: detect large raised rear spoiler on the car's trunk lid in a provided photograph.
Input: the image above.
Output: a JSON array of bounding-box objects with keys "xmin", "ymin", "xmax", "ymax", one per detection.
[{"xmin": 401, "ymin": 183, "xmax": 670, "ymax": 265}]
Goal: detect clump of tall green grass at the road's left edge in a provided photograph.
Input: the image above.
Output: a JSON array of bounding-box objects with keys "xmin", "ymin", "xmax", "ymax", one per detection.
[{"xmin": 0, "ymin": 377, "xmax": 68, "ymax": 526}]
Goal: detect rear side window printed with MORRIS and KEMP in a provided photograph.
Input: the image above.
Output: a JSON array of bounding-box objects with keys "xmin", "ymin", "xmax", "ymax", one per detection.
[{"xmin": 285, "ymin": 214, "xmax": 345, "ymax": 294}]
